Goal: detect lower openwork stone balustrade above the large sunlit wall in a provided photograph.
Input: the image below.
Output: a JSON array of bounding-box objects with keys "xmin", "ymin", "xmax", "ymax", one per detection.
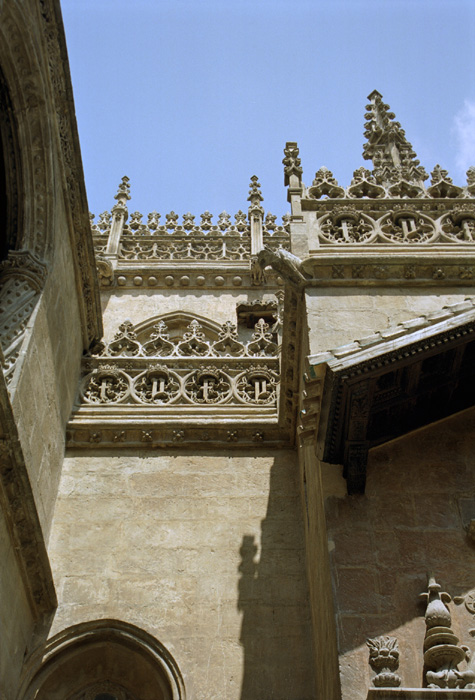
[{"xmin": 80, "ymin": 318, "xmax": 279, "ymax": 406}]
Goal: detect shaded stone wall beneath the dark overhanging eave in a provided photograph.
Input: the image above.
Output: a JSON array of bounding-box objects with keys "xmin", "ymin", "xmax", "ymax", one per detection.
[{"xmin": 325, "ymin": 409, "xmax": 475, "ymax": 700}]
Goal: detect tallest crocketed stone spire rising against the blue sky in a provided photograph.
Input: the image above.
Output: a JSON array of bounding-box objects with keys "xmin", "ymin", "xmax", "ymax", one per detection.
[{"xmin": 363, "ymin": 90, "xmax": 428, "ymax": 184}]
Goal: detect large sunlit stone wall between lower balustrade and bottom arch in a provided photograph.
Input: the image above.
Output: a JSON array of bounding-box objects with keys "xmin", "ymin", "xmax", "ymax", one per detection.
[{"xmin": 50, "ymin": 450, "xmax": 315, "ymax": 700}]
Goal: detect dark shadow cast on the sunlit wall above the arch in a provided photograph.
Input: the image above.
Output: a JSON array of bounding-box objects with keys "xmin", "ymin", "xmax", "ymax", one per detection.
[{"xmin": 238, "ymin": 458, "xmax": 315, "ymax": 700}]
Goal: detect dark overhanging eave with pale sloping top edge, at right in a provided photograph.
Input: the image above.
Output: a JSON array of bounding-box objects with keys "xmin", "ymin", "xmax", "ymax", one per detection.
[{"xmin": 309, "ymin": 300, "xmax": 475, "ymax": 494}]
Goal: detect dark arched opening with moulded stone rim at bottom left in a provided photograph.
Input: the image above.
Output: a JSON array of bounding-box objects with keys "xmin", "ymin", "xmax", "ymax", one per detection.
[{"xmin": 18, "ymin": 620, "xmax": 185, "ymax": 700}]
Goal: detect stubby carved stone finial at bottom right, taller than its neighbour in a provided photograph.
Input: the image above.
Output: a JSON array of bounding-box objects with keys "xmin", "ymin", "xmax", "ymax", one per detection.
[{"xmin": 421, "ymin": 576, "xmax": 475, "ymax": 688}]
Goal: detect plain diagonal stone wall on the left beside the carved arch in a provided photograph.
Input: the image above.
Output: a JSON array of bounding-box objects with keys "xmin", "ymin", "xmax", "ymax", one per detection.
[{"xmin": 12, "ymin": 241, "xmax": 82, "ymax": 540}]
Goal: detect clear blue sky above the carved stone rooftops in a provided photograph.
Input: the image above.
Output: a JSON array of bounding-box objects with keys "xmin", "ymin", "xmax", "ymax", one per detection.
[{"xmin": 61, "ymin": 0, "xmax": 475, "ymax": 218}]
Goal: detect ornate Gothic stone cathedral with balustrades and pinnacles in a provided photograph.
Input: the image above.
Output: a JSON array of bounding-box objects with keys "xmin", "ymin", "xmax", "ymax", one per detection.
[{"xmin": 0, "ymin": 0, "xmax": 475, "ymax": 700}]
